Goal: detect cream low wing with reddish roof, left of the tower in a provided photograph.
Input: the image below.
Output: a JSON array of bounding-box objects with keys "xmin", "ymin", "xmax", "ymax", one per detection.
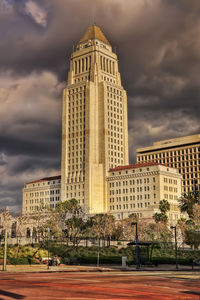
[{"xmin": 22, "ymin": 176, "xmax": 61, "ymax": 214}]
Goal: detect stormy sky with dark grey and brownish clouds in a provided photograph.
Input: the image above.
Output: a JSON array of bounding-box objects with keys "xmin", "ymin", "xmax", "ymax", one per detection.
[{"xmin": 0, "ymin": 0, "xmax": 200, "ymax": 212}]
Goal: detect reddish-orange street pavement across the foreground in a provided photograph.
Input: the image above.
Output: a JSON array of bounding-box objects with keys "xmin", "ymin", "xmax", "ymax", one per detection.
[{"xmin": 0, "ymin": 272, "xmax": 200, "ymax": 300}]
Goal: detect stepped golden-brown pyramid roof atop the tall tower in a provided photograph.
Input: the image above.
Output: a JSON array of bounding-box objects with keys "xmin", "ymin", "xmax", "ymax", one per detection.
[{"xmin": 79, "ymin": 25, "xmax": 110, "ymax": 45}]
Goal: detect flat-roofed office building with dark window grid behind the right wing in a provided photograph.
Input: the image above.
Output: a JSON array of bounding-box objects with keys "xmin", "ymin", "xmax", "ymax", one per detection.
[{"xmin": 137, "ymin": 134, "xmax": 200, "ymax": 193}]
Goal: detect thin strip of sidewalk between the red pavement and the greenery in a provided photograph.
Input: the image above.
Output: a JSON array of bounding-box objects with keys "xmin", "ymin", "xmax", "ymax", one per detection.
[{"xmin": 0, "ymin": 265, "xmax": 200, "ymax": 273}]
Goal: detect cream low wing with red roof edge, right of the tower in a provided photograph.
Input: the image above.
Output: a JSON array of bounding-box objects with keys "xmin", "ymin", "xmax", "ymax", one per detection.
[{"xmin": 107, "ymin": 162, "xmax": 181, "ymax": 223}]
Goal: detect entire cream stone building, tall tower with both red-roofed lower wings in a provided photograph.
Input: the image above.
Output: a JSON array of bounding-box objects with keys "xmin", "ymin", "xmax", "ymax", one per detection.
[{"xmin": 23, "ymin": 25, "xmax": 184, "ymax": 220}]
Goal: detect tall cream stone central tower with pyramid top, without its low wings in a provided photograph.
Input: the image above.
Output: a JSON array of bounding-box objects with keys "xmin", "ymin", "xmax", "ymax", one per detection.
[{"xmin": 61, "ymin": 25, "xmax": 129, "ymax": 213}]
